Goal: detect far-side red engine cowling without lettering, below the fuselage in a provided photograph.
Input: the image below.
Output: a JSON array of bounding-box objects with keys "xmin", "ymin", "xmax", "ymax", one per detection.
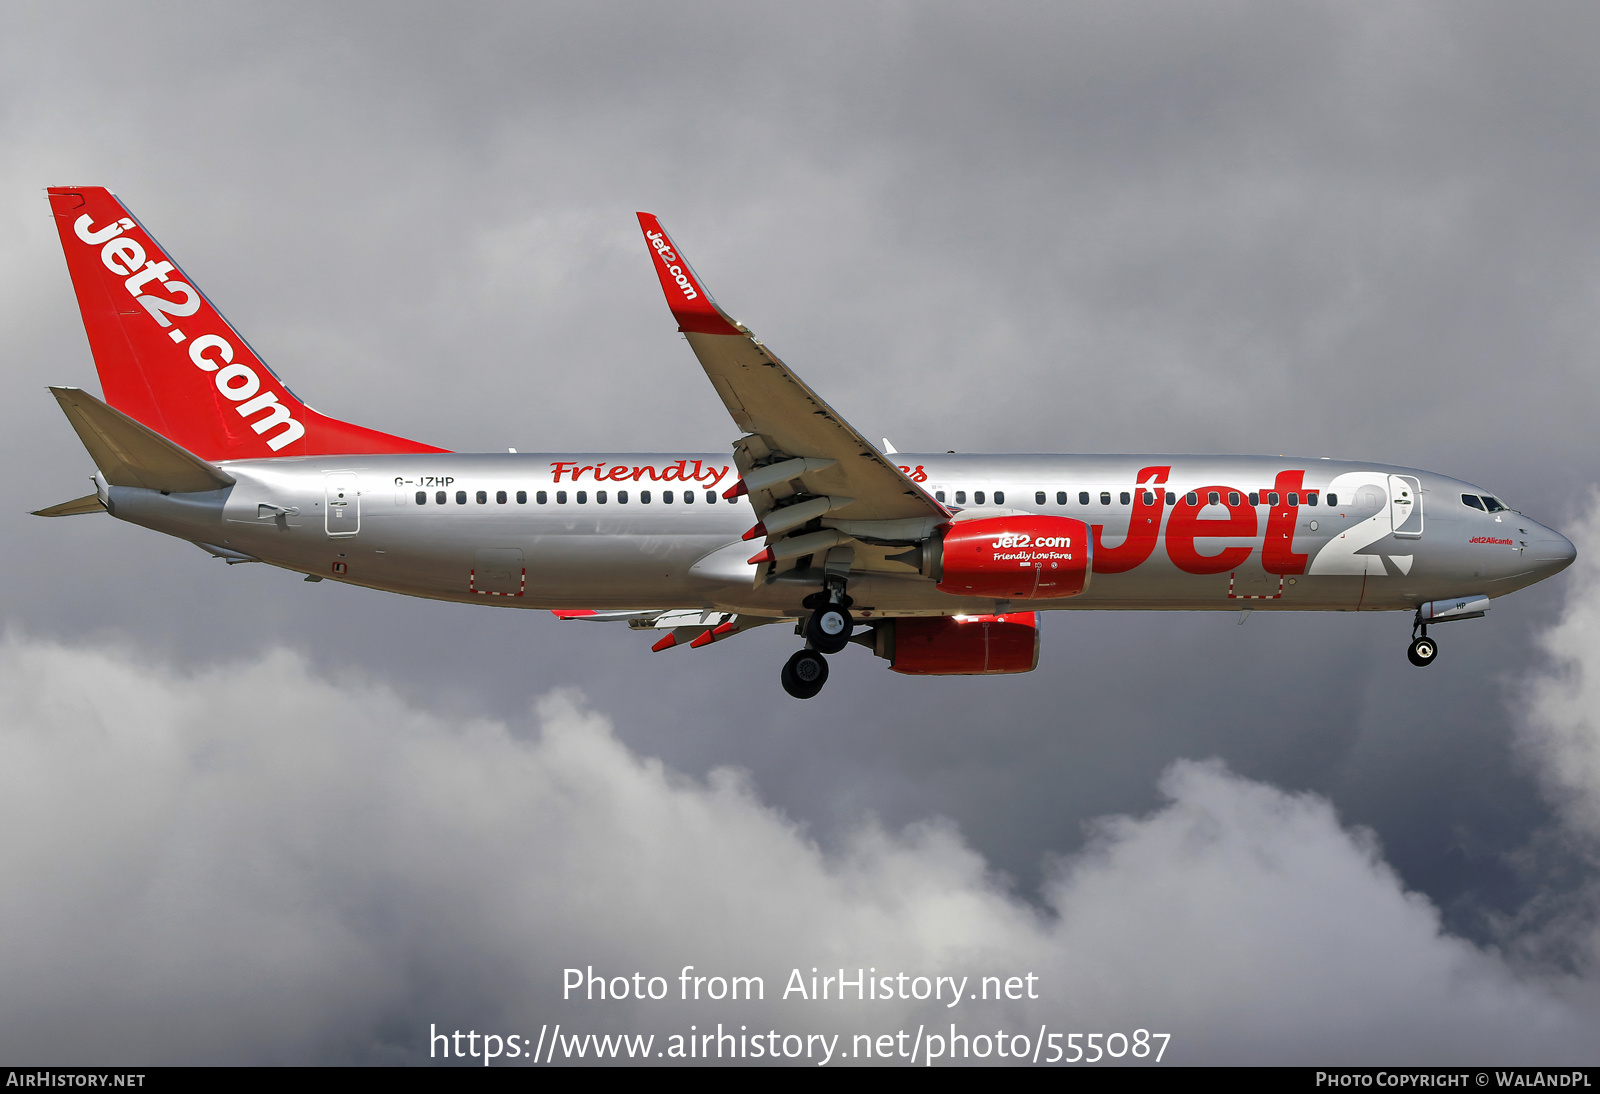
[{"xmin": 872, "ymin": 611, "xmax": 1038, "ymax": 677}]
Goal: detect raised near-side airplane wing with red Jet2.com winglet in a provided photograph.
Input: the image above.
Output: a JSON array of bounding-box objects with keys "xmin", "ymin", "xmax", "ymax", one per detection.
[{"xmin": 638, "ymin": 213, "xmax": 950, "ymax": 547}]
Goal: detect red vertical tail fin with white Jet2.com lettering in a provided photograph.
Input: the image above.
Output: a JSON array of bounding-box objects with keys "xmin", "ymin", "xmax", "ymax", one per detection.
[{"xmin": 50, "ymin": 186, "xmax": 446, "ymax": 461}]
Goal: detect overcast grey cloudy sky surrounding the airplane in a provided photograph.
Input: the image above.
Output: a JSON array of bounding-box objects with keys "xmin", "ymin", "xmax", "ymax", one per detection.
[{"xmin": 0, "ymin": 3, "xmax": 1600, "ymax": 1064}]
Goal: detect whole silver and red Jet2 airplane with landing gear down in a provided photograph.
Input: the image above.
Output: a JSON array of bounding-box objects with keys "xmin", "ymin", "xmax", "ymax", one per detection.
[{"xmin": 40, "ymin": 187, "xmax": 1574, "ymax": 697}]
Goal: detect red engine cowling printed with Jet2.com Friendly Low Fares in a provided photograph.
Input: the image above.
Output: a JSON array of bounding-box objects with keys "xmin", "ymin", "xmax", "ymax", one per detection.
[{"xmin": 934, "ymin": 515, "xmax": 1093, "ymax": 600}]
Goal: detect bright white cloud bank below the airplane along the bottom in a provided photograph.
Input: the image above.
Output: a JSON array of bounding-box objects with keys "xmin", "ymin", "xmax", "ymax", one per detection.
[{"xmin": 0, "ymin": 626, "xmax": 1595, "ymax": 1062}]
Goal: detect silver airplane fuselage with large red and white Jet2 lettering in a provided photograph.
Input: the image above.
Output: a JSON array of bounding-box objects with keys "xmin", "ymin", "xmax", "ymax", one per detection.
[{"xmin": 102, "ymin": 453, "xmax": 1574, "ymax": 617}]
